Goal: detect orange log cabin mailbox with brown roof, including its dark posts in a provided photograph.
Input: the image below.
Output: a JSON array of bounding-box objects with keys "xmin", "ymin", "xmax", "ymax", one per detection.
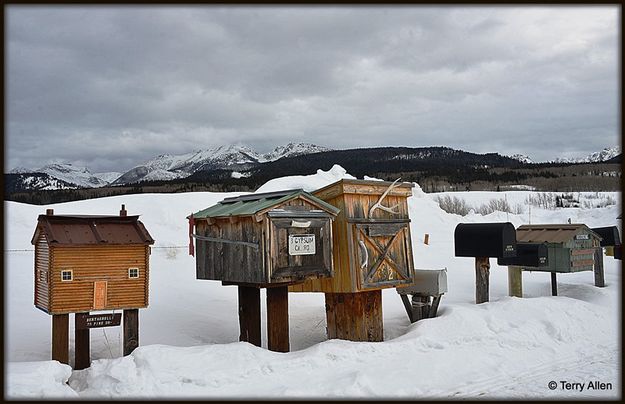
[{"xmin": 31, "ymin": 205, "xmax": 154, "ymax": 369}]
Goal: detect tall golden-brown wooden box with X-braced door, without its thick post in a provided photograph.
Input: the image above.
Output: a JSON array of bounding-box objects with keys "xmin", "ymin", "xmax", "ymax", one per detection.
[{"xmin": 289, "ymin": 183, "xmax": 414, "ymax": 293}]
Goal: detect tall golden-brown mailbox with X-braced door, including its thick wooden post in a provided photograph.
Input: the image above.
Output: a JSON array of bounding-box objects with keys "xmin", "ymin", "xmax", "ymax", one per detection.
[{"xmin": 289, "ymin": 179, "xmax": 414, "ymax": 341}]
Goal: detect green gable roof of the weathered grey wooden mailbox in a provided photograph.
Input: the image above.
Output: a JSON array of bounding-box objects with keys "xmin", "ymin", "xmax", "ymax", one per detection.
[{"xmin": 187, "ymin": 189, "xmax": 340, "ymax": 219}]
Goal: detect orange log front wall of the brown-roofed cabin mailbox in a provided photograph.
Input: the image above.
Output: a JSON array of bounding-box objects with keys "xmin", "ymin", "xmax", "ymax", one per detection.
[{"xmin": 49, "ymin": 245, "xmax": 149, "ymax": 314}]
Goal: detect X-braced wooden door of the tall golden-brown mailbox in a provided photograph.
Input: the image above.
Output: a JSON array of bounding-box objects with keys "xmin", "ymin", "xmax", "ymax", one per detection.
[{"xmin": 348, "ymin": 219, "xmax": 414, "ymax": 289}]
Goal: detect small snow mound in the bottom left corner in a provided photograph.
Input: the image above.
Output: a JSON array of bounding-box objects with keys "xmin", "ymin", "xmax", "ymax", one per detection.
[{"xmin": 6, "ymin": 361, "xmax": 78, "ymax": 399}]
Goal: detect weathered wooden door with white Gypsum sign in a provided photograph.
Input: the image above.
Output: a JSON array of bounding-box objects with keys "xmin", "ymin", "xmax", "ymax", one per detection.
[{"xmin": 269, "ymin": 217, "xmax": 332, "ymax": 282}]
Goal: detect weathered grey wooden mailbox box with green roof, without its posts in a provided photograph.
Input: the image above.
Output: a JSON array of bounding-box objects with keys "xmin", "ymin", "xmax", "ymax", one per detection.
[{"xmin": 189, "ymin": 189, "xmax": 338, "ymax": 286}]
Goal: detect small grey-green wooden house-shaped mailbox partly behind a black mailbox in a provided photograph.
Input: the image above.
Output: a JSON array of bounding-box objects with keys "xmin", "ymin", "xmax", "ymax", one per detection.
[{"xmin": 516, "ymin": 223, "xmax": 601, "ymax": 272}]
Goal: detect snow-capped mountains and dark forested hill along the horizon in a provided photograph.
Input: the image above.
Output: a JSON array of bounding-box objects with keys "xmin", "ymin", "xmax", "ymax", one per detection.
[{"xmin": 5, "ymin": 143, "xmax": 621, "ymax": 192}]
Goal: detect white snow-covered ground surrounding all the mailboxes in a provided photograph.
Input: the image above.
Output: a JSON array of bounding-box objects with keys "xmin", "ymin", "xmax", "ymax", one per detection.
[{"xmin": 4, "ymin": 166, "xmax": 622, "ymax": 399}]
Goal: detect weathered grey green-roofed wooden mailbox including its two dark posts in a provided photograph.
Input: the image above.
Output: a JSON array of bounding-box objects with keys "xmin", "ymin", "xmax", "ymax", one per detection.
[{"xmin": 187, "ymin": 189, "xmax": 339, "ymax": 352}]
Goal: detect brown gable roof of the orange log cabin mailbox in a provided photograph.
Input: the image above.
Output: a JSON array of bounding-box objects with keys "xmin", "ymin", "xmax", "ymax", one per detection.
[{"xmin": 30, "ymin": 215, "xmax": 154, "ymax": 246}]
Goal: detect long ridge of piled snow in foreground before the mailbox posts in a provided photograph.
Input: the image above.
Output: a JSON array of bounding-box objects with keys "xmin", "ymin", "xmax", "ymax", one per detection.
[{"xmin": 70, "ymin": 297, "xmax": 617, "ymax": 399}]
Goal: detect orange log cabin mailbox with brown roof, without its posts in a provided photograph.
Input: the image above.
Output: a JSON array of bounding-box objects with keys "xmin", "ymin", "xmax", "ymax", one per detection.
[{"xmin": 31, "ymin": 206, "xmax": 154, "ymax": 314}]
